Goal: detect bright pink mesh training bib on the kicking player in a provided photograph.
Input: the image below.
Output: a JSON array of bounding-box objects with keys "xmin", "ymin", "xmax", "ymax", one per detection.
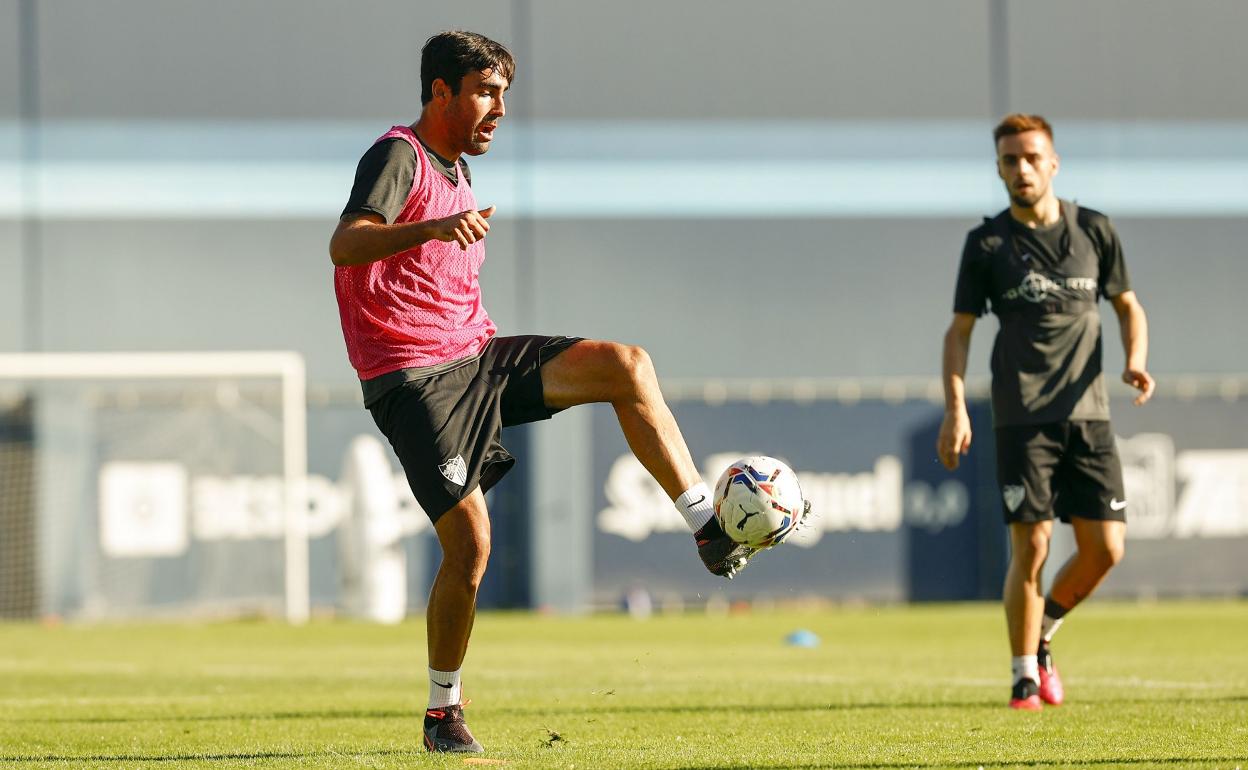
[{"xmin": 333, "ymin": 126, "xmax": 497, "ymax": 379}]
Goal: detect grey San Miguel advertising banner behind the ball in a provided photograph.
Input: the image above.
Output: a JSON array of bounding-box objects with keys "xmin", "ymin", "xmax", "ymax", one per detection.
[{"xmin": 593, "ymin": 401, "xmax": 948, "ymax": 604}]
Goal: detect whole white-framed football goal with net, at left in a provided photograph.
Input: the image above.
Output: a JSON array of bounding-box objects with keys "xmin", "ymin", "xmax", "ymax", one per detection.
[{"xmin": 0, "ymin": 352, "xmax": 308, "ymax": 623}]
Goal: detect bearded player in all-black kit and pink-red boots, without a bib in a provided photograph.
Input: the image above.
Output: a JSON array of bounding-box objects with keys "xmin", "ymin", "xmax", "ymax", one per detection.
[{"xmin": 936, "ymin": 115, "xmax": 1153, "ymax": 710}]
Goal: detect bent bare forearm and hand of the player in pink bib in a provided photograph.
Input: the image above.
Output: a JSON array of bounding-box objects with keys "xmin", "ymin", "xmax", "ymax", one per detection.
[{"xmin": 329, "ymin": 206, "xmax": 494, "ymax": 267}]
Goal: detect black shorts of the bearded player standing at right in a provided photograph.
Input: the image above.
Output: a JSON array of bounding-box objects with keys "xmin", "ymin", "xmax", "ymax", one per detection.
[{"xmin": 996, "ymin": 419, "xmax": 1127, "ymax": 523}]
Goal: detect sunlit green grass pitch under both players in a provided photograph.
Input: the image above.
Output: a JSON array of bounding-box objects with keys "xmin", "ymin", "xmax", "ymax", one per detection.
[{"xmin": 0, "ymin": 602, "xmax": 1248, "ymax": 770}]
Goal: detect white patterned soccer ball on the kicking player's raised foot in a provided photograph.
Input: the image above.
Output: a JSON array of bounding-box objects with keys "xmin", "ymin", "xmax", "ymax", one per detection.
[{"xmin": 714, "ymin": 457, "xmax": 806, "ymax": 548}]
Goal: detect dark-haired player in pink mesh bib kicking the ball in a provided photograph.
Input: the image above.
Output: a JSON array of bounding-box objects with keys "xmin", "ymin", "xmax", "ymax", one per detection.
[{"xmin": 329, "ymin": 31, "xmax": 753, "ymax": 753}]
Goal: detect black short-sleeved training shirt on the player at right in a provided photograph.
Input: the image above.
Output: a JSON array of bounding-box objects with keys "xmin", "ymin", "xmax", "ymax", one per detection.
[{"xmin": 953, "ymin": 201, "xmax": 1129, "ymax": 427}]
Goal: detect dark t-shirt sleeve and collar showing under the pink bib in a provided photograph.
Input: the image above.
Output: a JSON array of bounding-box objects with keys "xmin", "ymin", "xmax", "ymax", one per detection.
[{"xmin": 342, "ymin": 132, "xmax": 472, "ymax": 225}]
